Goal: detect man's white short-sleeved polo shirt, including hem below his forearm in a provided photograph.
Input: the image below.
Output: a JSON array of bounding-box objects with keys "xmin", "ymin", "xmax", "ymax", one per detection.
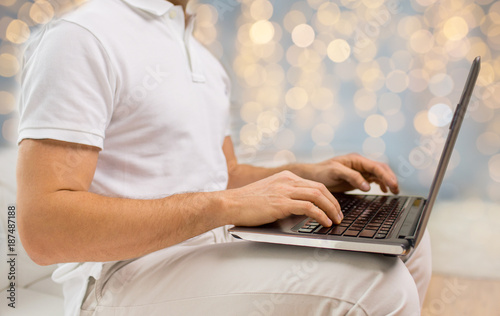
[{"xmin": 18, "ymin": 0, "xmax": 230, "ymax": 315}]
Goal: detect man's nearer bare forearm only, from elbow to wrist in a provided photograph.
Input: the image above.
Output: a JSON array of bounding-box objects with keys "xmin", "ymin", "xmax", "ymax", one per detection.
[{"xmin": 19, "ymin": 191, "xmax": 226, "ymax": 265}]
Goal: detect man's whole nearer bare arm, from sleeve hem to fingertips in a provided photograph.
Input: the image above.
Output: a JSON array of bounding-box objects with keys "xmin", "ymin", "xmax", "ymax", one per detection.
[{"xmin": 17, "ymin": 139, "xmax": 341, "ymax": 265}]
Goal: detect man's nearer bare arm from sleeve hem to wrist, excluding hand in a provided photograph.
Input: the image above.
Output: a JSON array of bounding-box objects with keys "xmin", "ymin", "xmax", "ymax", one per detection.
[{"xmin": 17, "ymin": 140, "xmax": 224, "ymax": 264}]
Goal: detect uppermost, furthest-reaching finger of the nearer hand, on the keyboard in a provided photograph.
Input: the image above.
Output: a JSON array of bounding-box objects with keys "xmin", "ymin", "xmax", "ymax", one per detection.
[{"xmin": 290, "ymin": 187, "xmax": 343, "ymax": 224}]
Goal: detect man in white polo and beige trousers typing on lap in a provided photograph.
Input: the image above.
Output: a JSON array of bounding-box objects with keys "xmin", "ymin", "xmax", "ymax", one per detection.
[{"xmin": 17, "ymin": 0, "xmax": 430, "ymax": 315}]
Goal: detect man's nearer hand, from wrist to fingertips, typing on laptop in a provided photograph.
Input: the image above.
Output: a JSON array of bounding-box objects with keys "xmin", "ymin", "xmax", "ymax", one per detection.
[{"xmin": 219, "ymin": 171, "xmax": 343, "ymax": 226}]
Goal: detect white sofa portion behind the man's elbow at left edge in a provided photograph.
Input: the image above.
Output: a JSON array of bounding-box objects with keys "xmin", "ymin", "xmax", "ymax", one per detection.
[{"xmin": 0, "ymin": 147, "xmax": 64, "ymax": 316}]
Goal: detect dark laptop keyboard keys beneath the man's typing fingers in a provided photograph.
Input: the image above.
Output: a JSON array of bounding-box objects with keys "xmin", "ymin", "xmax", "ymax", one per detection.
[{"xmin": 298, "ymin": 194, "xmax": 407, "ymax": 239}]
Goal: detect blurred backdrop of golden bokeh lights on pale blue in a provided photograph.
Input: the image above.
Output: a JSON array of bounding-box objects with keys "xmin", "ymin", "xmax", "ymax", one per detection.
[{"xmin": 0, "ymin": 0, "xmax": 500, "ymax": 201}]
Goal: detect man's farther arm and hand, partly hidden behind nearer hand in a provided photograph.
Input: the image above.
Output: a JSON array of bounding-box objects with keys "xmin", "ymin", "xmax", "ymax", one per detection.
[{"xmin": 223, "ymin": 136, "xmax": 399, "ymax": 194}]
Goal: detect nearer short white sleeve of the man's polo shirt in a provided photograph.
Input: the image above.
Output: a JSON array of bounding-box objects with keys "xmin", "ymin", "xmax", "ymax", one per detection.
[{"xmin": 18, "ymin": 20, "xmax": 116, "ymax": 149}]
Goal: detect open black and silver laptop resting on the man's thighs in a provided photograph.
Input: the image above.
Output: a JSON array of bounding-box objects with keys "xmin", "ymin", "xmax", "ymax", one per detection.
[{"xmin": 229, "ymin": 56, "xmax": 481, "ymax": 256}]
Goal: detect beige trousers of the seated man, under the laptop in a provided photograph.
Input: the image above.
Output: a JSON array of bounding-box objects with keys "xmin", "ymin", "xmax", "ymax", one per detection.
[{"xmin": 81, "ymin": 228, "xmax": 431, "ymax": 316}]
